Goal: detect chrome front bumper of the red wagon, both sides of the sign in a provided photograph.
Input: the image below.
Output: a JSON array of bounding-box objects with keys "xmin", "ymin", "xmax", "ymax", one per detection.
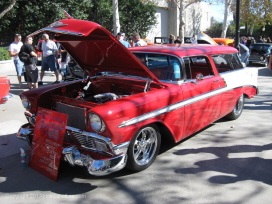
[{"xmin": 17, "ymin": 123, "xmax": 129, "ymax": 176}]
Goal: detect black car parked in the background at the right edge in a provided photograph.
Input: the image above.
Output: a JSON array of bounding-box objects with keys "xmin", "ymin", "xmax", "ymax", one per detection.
[{"xmin": 248, "ymin": 43, "xmax": 272, "ymax": 67}]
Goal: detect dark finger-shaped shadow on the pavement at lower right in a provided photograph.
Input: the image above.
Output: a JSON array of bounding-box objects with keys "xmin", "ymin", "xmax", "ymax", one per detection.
[{"xmin": 173, "ymin": 144, "xmax": 272, "ymax": 185}]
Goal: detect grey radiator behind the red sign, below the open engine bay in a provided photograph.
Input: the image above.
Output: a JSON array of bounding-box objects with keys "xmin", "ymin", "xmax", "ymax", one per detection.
[{"xmin": 56, "ymin": 102, "xmax": 86, "ymax": 130}]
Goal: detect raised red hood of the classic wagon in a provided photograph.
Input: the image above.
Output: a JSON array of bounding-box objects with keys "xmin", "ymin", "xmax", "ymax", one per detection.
[{"xmin": 30, "ymin": 18, "xmax": 160, "ymax": 83}]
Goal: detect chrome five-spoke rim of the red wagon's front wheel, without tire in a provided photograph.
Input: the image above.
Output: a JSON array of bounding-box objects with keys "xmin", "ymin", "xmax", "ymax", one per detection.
[{"xmin": 133, "ymin": 127, "xmax": 158, "ymax": 166}]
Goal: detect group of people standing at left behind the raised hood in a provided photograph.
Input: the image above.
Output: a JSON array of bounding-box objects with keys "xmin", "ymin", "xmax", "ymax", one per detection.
[{"xmin": 8, "ymin": 34, "xmax": 72, "ymax": 89}]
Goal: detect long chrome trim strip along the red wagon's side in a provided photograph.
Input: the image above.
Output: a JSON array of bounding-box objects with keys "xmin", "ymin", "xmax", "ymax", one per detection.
[{"xmin": 118, "ymin": 85, "xmax": 252, "ymax": 128}]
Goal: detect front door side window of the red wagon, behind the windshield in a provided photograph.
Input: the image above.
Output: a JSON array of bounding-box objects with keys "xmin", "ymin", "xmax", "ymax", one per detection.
[{"xmin": 183, "ymin": 56, "xmax": 214, "ymax": 80}]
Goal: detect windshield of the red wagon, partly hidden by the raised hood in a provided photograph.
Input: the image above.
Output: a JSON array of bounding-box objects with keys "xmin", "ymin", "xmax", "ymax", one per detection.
[{"xmin": 134, "ymin": 53, "xmax": 183, "ymax": 82}]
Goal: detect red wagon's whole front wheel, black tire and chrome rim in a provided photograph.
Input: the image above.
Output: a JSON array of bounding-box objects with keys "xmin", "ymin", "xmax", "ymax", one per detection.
[{"xmin": 127, "ymin": 125, "xmax": 161, "ymax": 171}]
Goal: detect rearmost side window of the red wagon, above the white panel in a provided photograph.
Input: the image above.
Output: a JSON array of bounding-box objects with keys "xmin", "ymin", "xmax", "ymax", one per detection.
[{"xmin": 212, "ymin": 53, "xmax": 243, "ymax": 73}]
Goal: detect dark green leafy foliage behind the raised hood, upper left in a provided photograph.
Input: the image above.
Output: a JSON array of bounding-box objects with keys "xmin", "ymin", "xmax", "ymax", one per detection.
[{"xmin": 0, "ymin": 0, "xmax": 156, "ymax": 45}]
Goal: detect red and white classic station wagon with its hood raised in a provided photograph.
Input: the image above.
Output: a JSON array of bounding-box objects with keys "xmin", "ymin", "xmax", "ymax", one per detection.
[{"xmin": 17, "ymin": 18, "xmax": 258, "ymax": 176}]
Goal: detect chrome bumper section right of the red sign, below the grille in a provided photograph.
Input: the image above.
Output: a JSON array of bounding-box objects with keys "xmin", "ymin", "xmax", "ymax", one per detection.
[{"xmin": 62, "ymin": 146, "xmax": 127, "ymax": 176}]
